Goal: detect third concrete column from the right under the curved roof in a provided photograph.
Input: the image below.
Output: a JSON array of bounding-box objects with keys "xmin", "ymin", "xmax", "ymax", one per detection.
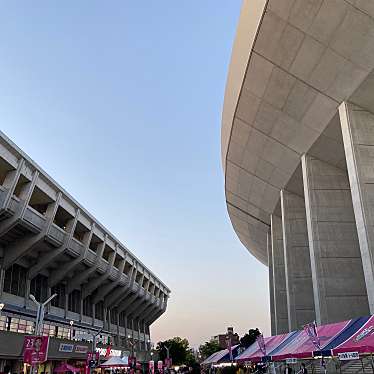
[{"xmin": 280, "ymin": 190, "xmax": 316, "ymax": 331}]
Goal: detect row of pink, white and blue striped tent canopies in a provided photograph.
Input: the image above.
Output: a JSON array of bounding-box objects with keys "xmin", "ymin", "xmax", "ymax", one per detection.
[{"xmin": 203, "ymin": 316, "xmax": 374, "ymax": 365}]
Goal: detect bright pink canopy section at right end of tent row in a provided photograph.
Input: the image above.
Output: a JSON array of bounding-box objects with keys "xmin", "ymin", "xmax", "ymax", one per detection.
[{"xmin": 332, "ymin": 316, "xmax": 374, "ymax": 355}]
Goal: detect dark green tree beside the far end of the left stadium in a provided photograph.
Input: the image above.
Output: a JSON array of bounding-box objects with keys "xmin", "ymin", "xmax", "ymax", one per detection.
[{"xmin": 156, "ymin": 336, "xmax": 195, "ymax": 366}]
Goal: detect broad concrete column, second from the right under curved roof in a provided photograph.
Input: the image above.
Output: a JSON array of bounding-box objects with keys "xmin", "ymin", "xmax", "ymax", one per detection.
[{"xmin": 302, "ymin": 155, "xmax": 369, "ymax": 324}]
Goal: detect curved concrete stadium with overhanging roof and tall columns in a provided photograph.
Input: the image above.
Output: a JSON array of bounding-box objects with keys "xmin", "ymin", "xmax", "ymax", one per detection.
[{"xmin": 222, "ymin": 0, "xmax": 374, "ymax": 334}]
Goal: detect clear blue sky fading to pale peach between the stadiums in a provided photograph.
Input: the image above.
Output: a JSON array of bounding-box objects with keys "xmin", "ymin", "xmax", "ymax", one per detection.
[{"xmin": 0, "ymin": 0, "xmax": 269, "ymax": 345}]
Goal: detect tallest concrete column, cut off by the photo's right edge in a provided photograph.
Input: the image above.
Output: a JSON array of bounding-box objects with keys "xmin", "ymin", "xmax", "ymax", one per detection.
[{"xmin": 339, "ymin": 103, "xmax": 374, "ymax": 314}]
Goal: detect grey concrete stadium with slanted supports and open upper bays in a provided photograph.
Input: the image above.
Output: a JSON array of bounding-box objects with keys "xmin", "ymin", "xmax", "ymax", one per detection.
[{"xmin": 0, "ymin": 133, "xmax": 170, "ymax": 364}]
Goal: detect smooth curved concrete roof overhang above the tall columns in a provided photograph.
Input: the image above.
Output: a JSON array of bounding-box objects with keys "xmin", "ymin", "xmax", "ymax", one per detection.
[{"xmin": 222, "ymin": 0, "xmax": 374, "ymax": 264}]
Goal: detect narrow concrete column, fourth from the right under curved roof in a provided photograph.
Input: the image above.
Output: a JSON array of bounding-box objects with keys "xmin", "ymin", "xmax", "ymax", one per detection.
[{"xmin": 271, "ymin": 215, "xmax": 288, "ymax": 334}]
